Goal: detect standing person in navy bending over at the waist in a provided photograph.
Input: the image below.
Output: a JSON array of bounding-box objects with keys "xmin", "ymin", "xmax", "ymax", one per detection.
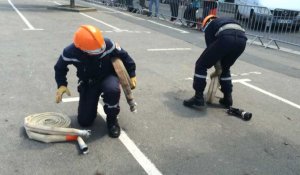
[{"xmin": 183, "ymin": 15, "xmax": 247, "ymax": 107}]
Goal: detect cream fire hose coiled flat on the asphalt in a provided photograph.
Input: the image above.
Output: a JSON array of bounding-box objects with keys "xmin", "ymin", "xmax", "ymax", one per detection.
[{"xmin": 24, "ymin": 112, "xmax": 91, "ymax": 154}]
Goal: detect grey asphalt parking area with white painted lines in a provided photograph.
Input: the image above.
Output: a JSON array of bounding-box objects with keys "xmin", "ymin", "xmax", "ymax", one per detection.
[{"xmin": 0, "ymin": 0, "xmax": 300, "ymax": 175}]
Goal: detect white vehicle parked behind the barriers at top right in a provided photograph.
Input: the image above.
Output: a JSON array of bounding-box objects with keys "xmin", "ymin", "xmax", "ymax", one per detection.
[{"xmin": 235, "ymin": 0, "xmax": 300, "ymax": 31}]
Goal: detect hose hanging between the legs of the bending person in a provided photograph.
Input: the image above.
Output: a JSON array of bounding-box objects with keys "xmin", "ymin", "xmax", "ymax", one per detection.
[{"xmin": 206, "ymin": 61, "xmax": 222, "ymax": 103}]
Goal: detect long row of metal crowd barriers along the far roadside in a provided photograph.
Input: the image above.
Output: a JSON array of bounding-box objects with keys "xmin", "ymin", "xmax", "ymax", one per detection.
[{"xmin": 85, "ymin": 0, "xmax": 300, "ymax": 49}]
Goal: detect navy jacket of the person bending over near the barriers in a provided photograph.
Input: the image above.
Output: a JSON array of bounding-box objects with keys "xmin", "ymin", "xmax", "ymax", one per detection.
[{"xmin": 205, "ymin": 17, "xmax": 247, "ymax": 46}]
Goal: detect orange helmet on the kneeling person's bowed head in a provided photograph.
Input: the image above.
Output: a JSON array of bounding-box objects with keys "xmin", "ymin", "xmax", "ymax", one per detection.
[{"xmin": 74, "ymin": 25, "xmax": 106, "ymax": 55}]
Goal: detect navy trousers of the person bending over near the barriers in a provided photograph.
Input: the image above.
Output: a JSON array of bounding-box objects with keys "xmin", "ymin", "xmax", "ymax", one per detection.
[{"xmin": 193, "ymin": 34, "xmax": 247, "ymax": 94}]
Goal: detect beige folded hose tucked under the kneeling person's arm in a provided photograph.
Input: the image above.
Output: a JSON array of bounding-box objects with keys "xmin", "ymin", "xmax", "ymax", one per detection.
[{"xmin": 112, "ymin": 58, "xmax": 137, "ymax": 113}]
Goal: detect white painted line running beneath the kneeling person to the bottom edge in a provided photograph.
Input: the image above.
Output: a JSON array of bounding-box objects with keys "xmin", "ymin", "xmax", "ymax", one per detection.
[{"xmin": 62, "ymin": 97, "xmax": 162, "ymax": 175}]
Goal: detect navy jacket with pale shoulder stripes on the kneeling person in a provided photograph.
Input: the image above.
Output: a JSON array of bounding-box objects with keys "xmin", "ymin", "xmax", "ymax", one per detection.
[{"xmin": 54, "ymin": 38, "xmax": 136, "ymax": 87}]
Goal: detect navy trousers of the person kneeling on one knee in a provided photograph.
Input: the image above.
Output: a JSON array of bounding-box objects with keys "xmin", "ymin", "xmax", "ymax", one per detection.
[{"xmin": 77, "ymin": 75, "xmax": 121, "ymax": 127}]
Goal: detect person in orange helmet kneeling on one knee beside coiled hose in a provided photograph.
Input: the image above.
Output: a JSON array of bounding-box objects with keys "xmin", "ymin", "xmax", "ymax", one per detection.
[{"xmin": 54, "ymin": 25, "xmax": 136, "ymax": 138}]
